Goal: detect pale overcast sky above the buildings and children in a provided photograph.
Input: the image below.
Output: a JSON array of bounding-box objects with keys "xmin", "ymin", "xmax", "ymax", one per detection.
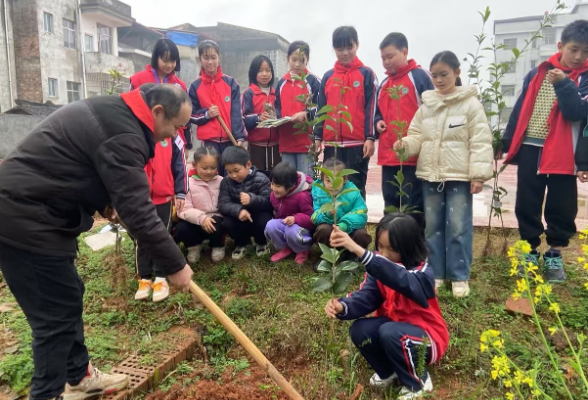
[{"xmin": 123, "ymin": 0, "xmax": 560, "ymax": 78}]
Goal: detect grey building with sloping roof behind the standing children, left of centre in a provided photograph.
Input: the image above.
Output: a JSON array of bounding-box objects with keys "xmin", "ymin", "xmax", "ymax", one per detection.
[{"xmin": 167, "ymin": 22, "xmax": 290, "ymax": 89}]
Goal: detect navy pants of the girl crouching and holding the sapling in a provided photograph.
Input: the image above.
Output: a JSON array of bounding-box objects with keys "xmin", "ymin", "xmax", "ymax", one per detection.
[{"xmin": 349, "ymin": 317, "xmax": 431, "ymax": 392}]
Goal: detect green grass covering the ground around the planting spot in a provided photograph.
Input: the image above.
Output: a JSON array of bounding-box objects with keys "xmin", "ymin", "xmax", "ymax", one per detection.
[{"xmin": 0, "ymin": 227, "xmax": 588, "ymax": 400}]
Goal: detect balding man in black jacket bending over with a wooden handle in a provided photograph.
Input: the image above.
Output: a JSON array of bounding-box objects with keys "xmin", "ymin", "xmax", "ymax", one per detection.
[{"xmin": 0, "ymin": 85, "xmax": 192, "ymax": 400}]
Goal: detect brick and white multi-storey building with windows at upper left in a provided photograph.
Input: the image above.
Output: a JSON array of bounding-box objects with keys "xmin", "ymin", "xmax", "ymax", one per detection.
[{"xmin": 0, "ymin": 0, "xmax": 135, "ymax": 110}]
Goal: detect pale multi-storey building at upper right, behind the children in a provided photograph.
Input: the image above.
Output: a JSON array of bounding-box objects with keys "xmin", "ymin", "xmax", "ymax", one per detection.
[{"xmin": 494, "ymin": 0, "xmax": 588, "ymax": 121}]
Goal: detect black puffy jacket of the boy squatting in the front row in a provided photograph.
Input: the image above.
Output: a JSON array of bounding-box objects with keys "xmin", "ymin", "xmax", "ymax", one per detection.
[{"xmin": 218, "ymin": 167, "xmax": 273, "ymax": 218}]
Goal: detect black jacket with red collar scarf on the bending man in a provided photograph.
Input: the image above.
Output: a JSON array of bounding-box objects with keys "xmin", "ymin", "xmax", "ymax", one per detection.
[{"xmin": 0, "ymin": 91, "xmax": 186, "ymax": 274}]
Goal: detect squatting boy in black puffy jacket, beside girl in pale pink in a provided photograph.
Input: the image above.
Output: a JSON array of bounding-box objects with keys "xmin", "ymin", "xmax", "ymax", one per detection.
[{"xmin": 218, "ymin": 146, "xmax": 273, "ymax": 260}]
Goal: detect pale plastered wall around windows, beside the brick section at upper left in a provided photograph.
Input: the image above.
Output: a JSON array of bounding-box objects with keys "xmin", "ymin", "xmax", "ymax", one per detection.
[{"xmin": 37, "ymin": 0, "xmax": 84, "ymax": 104}]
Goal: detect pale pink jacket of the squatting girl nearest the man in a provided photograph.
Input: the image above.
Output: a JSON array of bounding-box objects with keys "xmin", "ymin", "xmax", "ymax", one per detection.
[{"xmin": 178, "ymin": 170, "xmax": 223, "ymax": 225}]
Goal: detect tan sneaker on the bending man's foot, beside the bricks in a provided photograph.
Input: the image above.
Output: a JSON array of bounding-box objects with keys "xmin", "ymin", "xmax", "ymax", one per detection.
[{"xmin": 61, "ymin": 366, "xmax": 129, "ymax": 400}]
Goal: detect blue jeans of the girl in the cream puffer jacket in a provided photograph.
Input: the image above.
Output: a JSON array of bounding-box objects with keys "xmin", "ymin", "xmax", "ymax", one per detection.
[{"xmin": 423, "ymin": 181, "xmax": 474, "ymax": 281}]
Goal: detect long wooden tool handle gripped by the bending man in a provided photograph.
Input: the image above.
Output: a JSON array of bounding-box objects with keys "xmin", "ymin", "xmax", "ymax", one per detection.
[{"xmin": 190, "ymin": 282, "xmax": 304, "ymax": 400}]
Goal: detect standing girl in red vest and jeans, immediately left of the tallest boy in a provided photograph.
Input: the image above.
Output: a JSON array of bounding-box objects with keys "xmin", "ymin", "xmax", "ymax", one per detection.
[{"xmin": 276, "ymin": 40, "xmax": 321, "ymax": 176}]
